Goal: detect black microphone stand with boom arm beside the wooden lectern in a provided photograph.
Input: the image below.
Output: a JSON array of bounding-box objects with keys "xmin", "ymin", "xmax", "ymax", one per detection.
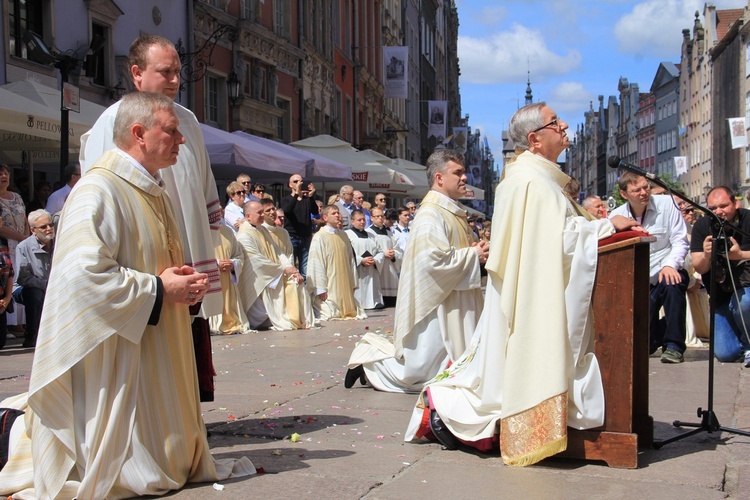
[{"xmin": 636, "ymin": 176, "xmax": 750, "ymax": 450}]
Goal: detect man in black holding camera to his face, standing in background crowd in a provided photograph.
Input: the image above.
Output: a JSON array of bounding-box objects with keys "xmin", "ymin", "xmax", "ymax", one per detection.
[{"xmin": 279, "ymin": 174, "xmax": 320, "ymax": 276}]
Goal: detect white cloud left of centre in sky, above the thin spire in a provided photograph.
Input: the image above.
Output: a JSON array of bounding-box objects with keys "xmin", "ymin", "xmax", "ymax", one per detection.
[{"xmin": 458, "ymin": 24, "xmax": 581, "ymax": 84}]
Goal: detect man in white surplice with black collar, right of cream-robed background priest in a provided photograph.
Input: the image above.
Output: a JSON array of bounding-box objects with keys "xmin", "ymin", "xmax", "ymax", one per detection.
[{"xmin": 345, "ymin": 209, "xmax": 385, "ymax": 310}]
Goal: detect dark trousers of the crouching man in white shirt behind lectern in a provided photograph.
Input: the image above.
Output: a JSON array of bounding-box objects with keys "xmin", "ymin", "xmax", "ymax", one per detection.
[{"xmin": 649, "ymin": 269, "xmax": 690, "ymax": 353}]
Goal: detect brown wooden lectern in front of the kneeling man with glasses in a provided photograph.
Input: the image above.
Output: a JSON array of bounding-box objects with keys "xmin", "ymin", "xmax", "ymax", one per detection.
[{"xmin": 558, "ymin": 236, "xmax": 656, "ymax": 469}]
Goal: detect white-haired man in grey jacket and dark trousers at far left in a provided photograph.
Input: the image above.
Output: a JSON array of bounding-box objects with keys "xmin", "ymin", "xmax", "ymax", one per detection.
[{"xmin": 15, "ymin": 210, "xmax": 55, "ymax": 347}]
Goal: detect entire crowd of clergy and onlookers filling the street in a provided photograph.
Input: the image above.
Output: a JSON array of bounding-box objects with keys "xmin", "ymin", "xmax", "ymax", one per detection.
[{"xmin": 0, "ymin": 35, "xmax": 750, "ymax": 498}]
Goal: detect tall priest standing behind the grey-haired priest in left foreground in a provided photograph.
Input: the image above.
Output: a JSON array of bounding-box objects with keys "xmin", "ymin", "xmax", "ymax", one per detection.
[{"xmin": 80, "ymin": 35, "xmax": 222, "ymax": 401}]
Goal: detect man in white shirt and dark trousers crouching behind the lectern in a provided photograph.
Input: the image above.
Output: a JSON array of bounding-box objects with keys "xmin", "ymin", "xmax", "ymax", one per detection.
[{"xmin": 610, "ymin": 172, "xmax": 690, "ymax": 364}]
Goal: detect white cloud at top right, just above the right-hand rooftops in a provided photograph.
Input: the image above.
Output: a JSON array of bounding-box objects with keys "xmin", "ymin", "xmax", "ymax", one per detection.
[{"xmin": 615, "ymin": 0, "xmax": 743, "ymax": 57}]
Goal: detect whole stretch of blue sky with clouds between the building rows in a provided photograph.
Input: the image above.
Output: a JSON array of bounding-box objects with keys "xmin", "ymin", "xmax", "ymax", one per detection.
[{"xmin": 456, "ymin": 0, "xmax": 747, "ymax": 169}]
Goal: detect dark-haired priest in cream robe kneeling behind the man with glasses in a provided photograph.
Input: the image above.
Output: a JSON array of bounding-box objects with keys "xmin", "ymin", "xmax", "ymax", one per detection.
[{"xmin": 344, "ymin": 150, "xmax": 489, "ymax": 392}]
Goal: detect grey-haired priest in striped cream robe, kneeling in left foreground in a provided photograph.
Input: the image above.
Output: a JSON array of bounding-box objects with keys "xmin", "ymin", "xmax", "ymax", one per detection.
[{"xmin": 0, "ymin": 92, "xmax": 255, "ymax": 499}]
